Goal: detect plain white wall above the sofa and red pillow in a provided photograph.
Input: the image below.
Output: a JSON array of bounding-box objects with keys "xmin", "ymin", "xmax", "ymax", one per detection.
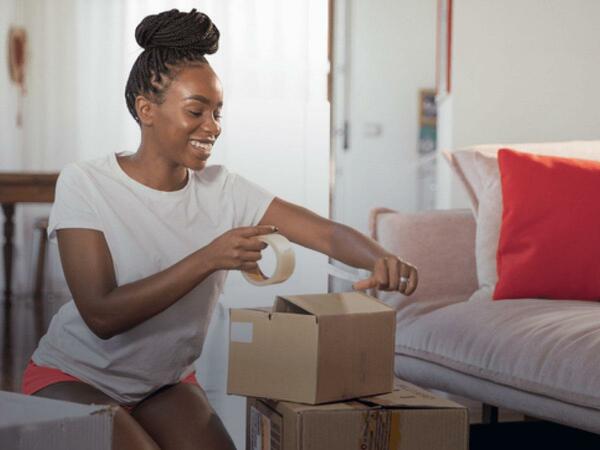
[{"xmin": 440, "ymin": 0, "xmax": 600, "ymax": 206}]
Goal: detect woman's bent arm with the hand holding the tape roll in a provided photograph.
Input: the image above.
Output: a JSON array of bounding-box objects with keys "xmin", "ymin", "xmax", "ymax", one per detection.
[{"xmin": 57, "ymin": 226, "xmax": 274, "ymax": 339}]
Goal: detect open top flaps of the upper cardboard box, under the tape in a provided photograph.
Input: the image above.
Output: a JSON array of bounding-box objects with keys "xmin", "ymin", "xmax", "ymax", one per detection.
[{"xmin": 273, "ymin": 291, "xmax": 393, "ymax": 316}]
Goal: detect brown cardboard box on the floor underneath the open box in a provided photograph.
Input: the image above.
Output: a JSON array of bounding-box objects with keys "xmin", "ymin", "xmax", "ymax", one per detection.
[{"xmin": 246, "ymin": 380, "xmax": 469, "ymax": 450}]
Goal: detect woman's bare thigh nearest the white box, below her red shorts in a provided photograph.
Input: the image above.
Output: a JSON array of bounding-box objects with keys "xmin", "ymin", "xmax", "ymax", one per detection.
[{"xmin": 32, "ymin": 381, "xmax": 159, "ymax": 450}]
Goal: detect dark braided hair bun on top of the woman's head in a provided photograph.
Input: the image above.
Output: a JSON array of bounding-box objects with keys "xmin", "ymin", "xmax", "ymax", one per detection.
[{"xmin": 135, "ymin": 8, "xmax": 220, "ymax": 55}]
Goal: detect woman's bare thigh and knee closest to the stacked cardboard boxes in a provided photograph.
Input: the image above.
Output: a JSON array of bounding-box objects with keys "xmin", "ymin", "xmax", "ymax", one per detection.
[{"xmin": 131, "ymin": 383, "xmax": 235, "ymax": 450}]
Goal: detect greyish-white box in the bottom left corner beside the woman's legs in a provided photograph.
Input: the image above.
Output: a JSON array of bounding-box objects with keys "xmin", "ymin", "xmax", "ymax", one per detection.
[{"xmin": 0, "ymin": 391, "xmax": 116, "ymax": 450}]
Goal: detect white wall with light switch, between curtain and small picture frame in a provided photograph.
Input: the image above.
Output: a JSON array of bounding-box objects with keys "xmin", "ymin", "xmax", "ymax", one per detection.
[{"xmin": 334, "ymin": 0, "xmax": 436, "ymax": 236}]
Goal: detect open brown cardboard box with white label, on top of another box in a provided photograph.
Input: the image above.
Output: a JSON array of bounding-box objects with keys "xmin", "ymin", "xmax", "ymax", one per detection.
[{"xmin": 227, "ymin": 292, "xmax": 396, "ymax": 404}]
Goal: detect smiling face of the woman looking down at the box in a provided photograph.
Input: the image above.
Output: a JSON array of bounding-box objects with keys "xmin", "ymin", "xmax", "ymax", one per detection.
[{"xmin": 152, "ymin": 64, "xmax": 223, "ymax": 170}]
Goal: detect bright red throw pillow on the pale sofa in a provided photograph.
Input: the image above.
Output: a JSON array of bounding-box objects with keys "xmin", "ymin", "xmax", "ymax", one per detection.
[{"xmin": 493, "ymin": 149, "xmax": 600, "ymax": 300}]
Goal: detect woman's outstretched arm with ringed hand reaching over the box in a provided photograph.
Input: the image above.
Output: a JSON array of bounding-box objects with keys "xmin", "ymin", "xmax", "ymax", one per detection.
[{"xmin": 261, "ymin": 198, "xmax": 418, "ymax": 295}]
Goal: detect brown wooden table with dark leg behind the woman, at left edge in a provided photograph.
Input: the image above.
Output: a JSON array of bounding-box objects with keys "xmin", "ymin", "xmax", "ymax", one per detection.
[{"xmin": 0, "ymin": 172, "xmax": 58, "ymax": 302}]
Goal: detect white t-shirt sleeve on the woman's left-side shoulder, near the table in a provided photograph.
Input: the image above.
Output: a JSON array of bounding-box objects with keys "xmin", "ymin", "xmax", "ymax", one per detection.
[{"xmin": 48, "ymin": 164, "xmax": 103, "ymax": 241}]
